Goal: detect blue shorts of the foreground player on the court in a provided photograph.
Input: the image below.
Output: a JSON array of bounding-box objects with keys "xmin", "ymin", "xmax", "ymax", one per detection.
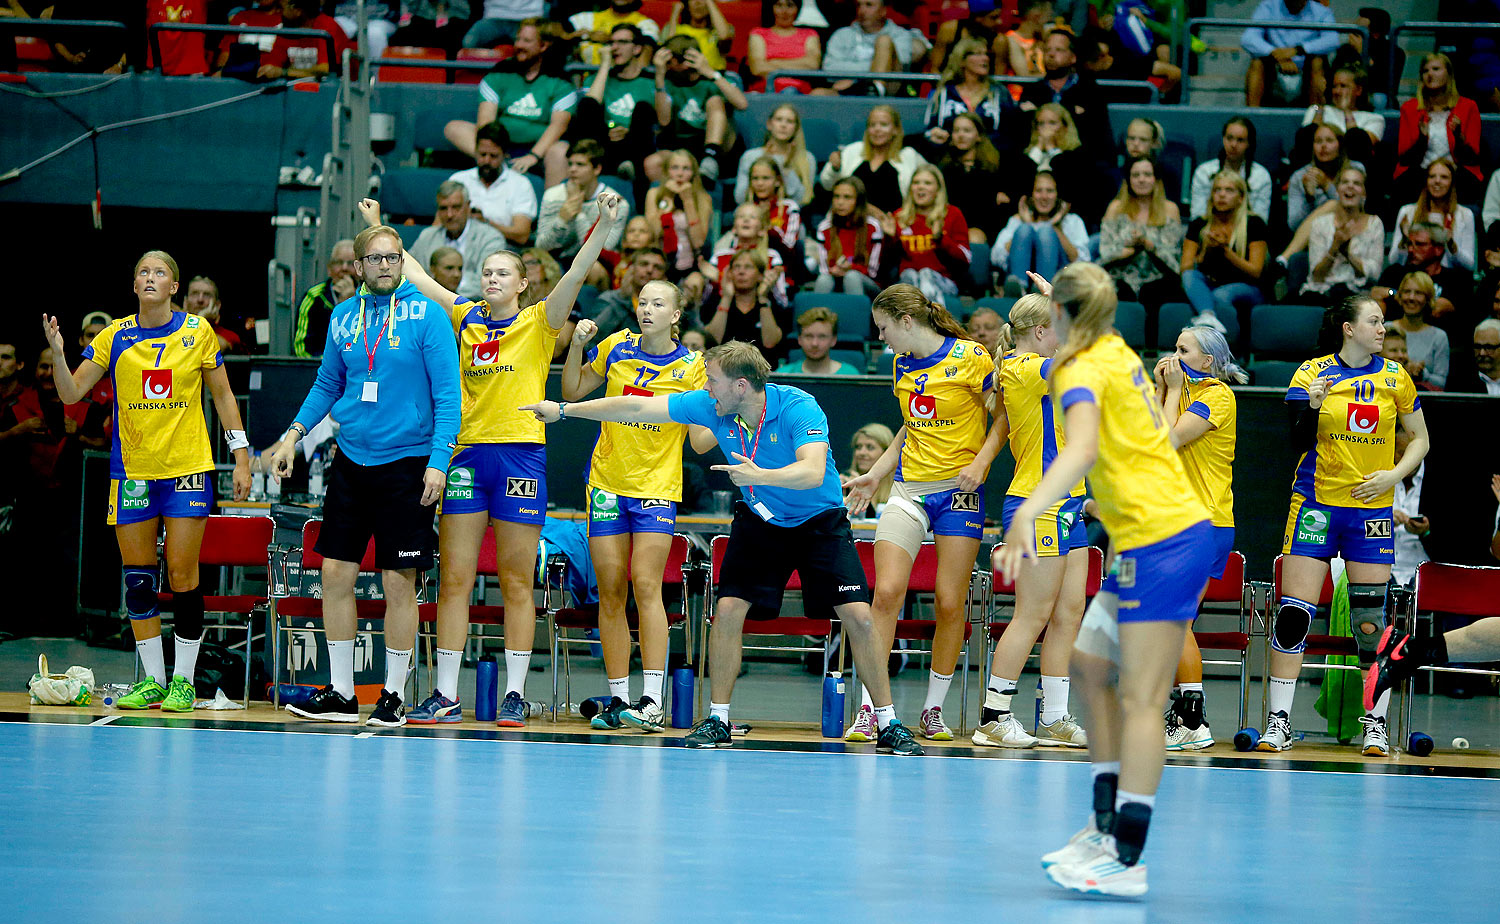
[{"xmin": 1100, "ymin": 521, "xmax": 1217, "ymax": 623}]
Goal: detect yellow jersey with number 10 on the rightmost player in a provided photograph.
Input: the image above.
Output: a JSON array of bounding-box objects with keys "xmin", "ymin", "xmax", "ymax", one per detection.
[{"xmin": 1287, "ymin": 354, "xmax": 1422, "ymax": 509}]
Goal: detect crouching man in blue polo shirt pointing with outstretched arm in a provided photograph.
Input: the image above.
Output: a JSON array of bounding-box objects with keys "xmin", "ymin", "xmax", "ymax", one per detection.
[{"xmin": 524, "ymin": 341, "xmax": 923, "ymax": 755}]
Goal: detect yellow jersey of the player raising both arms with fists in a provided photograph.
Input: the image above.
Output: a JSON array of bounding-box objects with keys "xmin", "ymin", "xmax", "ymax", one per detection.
[{"xmin": 453, "ymin": 299, "xmax": 558, "ymax": 446}]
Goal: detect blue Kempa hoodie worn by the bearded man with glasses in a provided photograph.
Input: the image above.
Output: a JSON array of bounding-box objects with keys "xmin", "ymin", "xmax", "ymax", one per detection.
[{"xmin": 297, "ymin": 279, "xmax": 462, "ymax": 471}]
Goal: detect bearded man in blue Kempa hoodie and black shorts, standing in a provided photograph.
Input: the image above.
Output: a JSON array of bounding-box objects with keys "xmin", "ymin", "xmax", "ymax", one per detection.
[{"xmin": 272, "ymin": 225, "xmax": 461, "ymax": 726}]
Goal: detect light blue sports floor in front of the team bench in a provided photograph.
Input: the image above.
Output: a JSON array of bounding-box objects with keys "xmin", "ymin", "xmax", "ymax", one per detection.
[{"xmin": 0, "ymin": 714, "xmax": 1500, "ymax": 924}]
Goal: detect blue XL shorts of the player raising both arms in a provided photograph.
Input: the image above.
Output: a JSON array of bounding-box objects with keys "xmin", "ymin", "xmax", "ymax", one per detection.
[{"xmin": 438, "ymin": 443, "xmax": 548, "ymax": 527}]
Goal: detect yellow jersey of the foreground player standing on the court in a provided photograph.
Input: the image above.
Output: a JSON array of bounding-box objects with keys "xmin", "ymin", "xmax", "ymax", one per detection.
[{"xmin": 1053, "ymin": 332, "xmax": 1209, "ymax": 552}]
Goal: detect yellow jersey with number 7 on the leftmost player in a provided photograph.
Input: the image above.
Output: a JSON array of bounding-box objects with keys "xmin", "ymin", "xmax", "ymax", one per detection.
[{"xmin": 84, "ymin": 311, "xmax": 224, "ymax": 480}]
